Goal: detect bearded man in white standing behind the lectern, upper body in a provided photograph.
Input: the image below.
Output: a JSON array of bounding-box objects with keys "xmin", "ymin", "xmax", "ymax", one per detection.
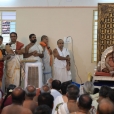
[{"xmin": 24, "ymin": 34, "xmax": 44, "ymax": 62}]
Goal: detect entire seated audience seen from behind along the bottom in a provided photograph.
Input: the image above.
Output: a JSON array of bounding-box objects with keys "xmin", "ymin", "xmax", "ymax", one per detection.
[{"xmin": 0, "ymin": 78, "xmax": 114, "ymax": 114}]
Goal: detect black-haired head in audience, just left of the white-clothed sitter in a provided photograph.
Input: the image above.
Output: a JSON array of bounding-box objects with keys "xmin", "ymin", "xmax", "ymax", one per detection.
[{"xmin": 38, "ymin": 93, "xmax": 54, "ymax": 110}]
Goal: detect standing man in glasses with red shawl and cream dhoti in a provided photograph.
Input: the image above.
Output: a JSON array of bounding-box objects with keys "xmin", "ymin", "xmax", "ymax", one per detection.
[{"xmin": 6, "ymin": 32, "xmax": 24, "ymax": 86}]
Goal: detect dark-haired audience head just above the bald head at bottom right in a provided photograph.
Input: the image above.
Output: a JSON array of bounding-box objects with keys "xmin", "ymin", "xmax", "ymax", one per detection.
[{"xmin": 97, "ymin": 85, "xmax": 111, "ymax": 103}]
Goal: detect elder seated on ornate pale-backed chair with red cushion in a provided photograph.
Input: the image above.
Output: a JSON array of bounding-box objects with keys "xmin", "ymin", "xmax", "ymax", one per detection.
[{"xmin": 95, "ymin": 46, "xmax": 114, "ymax": 76}]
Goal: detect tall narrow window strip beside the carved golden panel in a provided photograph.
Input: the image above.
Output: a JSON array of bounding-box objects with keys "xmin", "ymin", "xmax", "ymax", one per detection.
[{"xmin": 92, "ymin": 10, "xmax": 98, "ymax": 62}]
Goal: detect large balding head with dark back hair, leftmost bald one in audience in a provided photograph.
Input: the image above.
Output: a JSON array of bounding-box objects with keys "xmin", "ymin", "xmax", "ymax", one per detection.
[{"xmin": 11, "ymin": 87, "xmax": 25, "ymax": 104}]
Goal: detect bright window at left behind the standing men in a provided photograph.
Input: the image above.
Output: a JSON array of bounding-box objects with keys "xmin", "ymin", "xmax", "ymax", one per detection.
[{"xmin": 0, "ymin": 11, "xmax": 16, "ymax": 44}]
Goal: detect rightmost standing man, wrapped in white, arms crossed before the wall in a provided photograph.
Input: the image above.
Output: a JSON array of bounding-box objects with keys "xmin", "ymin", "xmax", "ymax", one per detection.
[{"xmin": 53, "ymin": 39, "xmax": 71, "ymax": 82}]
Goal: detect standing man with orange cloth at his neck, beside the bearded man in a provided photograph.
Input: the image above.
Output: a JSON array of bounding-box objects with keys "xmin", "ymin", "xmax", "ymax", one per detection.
[{"xmin": 40, "ymin": 35, "xmax": 52, "ymax": 84}]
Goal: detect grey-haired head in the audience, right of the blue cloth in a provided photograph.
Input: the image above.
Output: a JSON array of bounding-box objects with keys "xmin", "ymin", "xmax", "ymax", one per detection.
[{"xmin": 83, "ymin": 81, "xmax": 94, "ymax": 94}]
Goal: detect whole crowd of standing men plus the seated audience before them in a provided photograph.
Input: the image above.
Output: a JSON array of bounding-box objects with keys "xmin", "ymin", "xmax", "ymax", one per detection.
[{"xmin": 0, "ymin": 32, "xmax": 114, "ymax": 114}]
